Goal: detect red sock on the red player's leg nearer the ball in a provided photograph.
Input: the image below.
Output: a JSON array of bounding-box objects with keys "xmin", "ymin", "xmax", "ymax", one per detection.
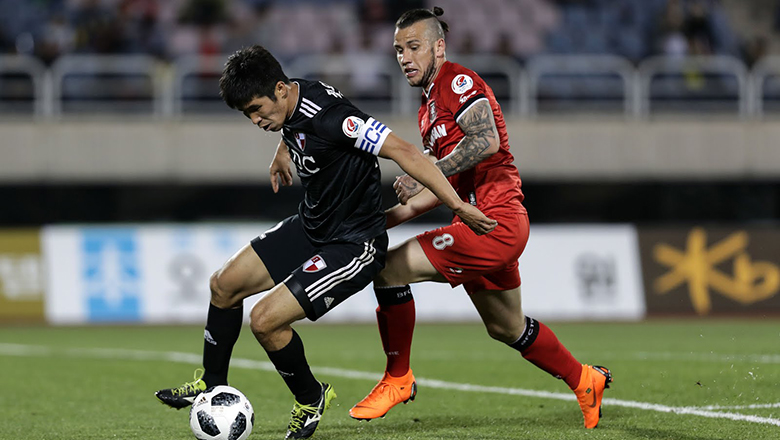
[{"xmin": 376, "ymin": 300, "xmax": 415, "ymax": 377}]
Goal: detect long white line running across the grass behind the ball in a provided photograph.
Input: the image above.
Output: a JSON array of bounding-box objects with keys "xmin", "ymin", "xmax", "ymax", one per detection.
[{"xmin": 0, "ymin": 343, "xmax": 780, "ymax": 426}]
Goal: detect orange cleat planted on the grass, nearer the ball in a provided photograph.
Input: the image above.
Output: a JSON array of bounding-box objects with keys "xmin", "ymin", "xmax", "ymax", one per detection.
[{"xmin": 349, "ymin": 370, "xmax": 417, "ymax": 420}]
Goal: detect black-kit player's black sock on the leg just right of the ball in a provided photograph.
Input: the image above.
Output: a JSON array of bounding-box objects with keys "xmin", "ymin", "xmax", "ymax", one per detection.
[{"xmin": 266, "ymin": 329, "xmax": 322, "ymax": 405}]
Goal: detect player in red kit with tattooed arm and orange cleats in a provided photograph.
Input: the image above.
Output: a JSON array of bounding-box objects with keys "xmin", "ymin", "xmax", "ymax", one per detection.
[{"xmin": 350, "ymin": 8, "xmax": 612, "ymax": 428}]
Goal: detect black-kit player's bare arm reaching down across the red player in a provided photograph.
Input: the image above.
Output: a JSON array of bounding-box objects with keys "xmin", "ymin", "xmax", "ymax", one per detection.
[{"xmin": 379, "ymin": 133, "xmax": 498, "ymax": 235}]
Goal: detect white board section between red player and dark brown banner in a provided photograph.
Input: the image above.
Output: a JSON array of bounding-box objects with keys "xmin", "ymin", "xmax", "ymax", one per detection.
[{"xmin": 520, "ymin": 225, "xmax": 645, "ymax": 320}]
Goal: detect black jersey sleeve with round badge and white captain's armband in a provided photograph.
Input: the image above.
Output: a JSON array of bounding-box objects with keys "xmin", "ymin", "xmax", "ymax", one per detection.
[{"xmin": 314, "ymin": 103, "xmax": 392, "ymax": 155}]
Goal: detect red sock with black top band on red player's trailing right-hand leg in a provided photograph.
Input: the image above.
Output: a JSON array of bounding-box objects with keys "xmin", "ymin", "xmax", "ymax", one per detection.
[{"xmin": 509, "ymin": 316, "xmax": 582, "ymax": 389}]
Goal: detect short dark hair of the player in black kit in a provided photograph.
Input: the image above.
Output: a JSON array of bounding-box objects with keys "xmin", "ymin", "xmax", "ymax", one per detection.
[{"xmin": 219, "ymin": 44, "xmax": 290, "ymax": 110}]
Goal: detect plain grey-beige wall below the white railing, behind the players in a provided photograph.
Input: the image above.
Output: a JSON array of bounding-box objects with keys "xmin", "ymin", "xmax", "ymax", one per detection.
[{"xmin": 0, "ymin": 118, "xmax": 780, "ymax": 184}]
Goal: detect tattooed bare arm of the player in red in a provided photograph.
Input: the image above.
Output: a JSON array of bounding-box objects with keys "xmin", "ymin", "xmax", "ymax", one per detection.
[{"xmin": 436, "ymin": 99, "xmax": 498, "ymax": 177}]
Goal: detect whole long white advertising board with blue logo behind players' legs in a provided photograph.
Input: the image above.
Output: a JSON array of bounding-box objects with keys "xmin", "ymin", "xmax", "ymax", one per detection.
[{"xmin": 42, "ymin": 223, "xmax": 645, "ymax": 324}]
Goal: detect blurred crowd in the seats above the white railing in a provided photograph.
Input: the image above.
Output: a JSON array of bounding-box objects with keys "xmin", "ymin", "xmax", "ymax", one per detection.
[{"xmin": 0, "ymin": 0, "xmax": 780, "ymax": 64}]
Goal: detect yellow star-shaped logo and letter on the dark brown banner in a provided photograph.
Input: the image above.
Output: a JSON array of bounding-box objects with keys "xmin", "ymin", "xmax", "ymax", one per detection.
[{"xmin": 653, "ymin": 228, "xmax": 780, "ymax": 315}]
